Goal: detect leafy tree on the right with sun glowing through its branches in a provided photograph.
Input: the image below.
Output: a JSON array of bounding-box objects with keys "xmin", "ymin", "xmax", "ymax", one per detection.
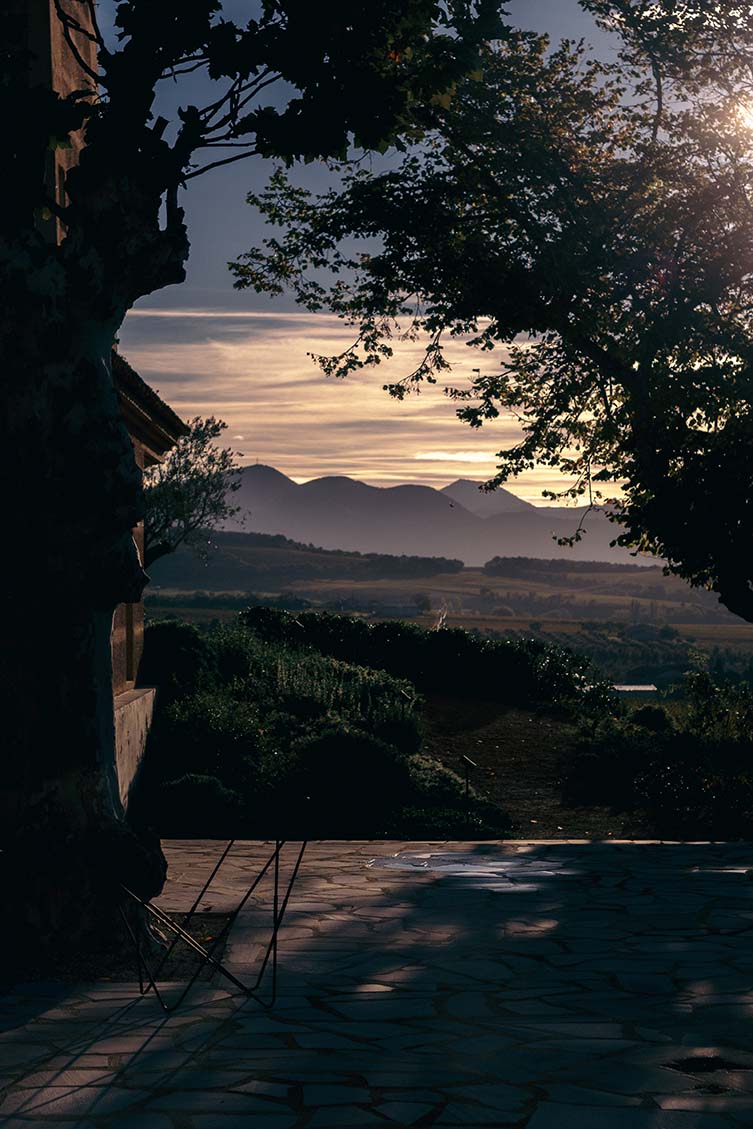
[{"xmin": 234, "ymin": 0, "xmax": 753, "ymax": 621}]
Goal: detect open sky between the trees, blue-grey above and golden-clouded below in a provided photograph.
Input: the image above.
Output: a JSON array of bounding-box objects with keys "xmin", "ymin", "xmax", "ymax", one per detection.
[{"xmin": 117, "ymin": 0, "xmax": 614, "ymax": 505}]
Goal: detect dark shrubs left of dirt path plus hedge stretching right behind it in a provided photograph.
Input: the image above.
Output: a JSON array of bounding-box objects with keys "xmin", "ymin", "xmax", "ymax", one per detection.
[{"xmin": 131, "ymin": 607, "xmax": 612, "ymax": 838}]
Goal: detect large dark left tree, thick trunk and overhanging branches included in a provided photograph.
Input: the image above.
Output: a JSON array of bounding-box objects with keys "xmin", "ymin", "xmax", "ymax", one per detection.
[{"xmin": 0, "ymin": 0, "xmax": 496, "ymax": 944}]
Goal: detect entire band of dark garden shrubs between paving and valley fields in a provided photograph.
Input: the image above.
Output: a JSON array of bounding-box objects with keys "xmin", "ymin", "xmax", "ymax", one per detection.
[{"xmin": 132, "ymin": 606, "xmax": 753, "ymax": 838}]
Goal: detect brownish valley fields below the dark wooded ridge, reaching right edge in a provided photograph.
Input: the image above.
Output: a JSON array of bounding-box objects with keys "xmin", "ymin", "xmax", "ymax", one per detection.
[{"xmin": 147, "ymin": 548, "xmax": 753, "ymax": 689}]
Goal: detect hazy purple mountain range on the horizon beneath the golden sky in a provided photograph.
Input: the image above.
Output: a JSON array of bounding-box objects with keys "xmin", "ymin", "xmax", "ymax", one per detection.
[{"xmin": 222, "ymin": 464, "xmax": 656, "ymax": 566}]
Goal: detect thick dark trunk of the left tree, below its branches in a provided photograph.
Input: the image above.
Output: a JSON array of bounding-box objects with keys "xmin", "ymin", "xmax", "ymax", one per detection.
[{"xmin": 0, "ymin": 329, "xmax": 165, "ymax": 953}]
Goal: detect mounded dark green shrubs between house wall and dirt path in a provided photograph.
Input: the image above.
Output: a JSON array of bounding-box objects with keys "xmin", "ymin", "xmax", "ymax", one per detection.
[{"xmin": 130, "ymin": 623, "xmax": 508, "ymax": 837}]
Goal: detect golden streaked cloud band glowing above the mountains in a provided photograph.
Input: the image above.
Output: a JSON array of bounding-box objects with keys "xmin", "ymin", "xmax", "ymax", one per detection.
[{"xmin": 121, "ymin": 308, "xmax": 578, "ymax": 502}]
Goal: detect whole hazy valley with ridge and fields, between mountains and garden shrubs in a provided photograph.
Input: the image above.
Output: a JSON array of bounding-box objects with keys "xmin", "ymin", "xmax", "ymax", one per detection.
[{"xmin": 147, "ymin": 533, "xmax": 753, "ymax": 688}]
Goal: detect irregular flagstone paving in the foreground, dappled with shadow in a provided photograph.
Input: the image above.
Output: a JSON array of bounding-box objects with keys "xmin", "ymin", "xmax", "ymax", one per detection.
[{"xmin": 0, "ymin": 841, "xmax": 753, "ymax": 1129}]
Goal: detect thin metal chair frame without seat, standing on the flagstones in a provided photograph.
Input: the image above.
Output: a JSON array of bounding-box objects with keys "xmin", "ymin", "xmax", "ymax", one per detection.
[{"xmin": 120, "ymin": 839, "xmax": 307, "ymax": 1013}]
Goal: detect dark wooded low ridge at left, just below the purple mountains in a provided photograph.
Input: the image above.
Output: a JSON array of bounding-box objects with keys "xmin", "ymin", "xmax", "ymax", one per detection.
[{"xmin": 151, "ymin": 532, "xmax": 463, "ymax": 592}]
